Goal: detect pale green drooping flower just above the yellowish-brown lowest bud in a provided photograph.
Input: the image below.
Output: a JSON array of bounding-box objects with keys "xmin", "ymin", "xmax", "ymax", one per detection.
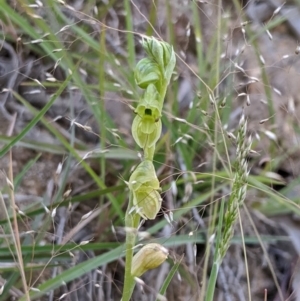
[{"xmin": 129, "ymin": 160, "xmax": 161, "ymax": 219}]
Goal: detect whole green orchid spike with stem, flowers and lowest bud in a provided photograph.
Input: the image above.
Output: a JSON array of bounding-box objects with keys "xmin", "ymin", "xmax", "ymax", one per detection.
[{"xmin": 122, "ymin": 38, "xmax": 176, "ymax": 301}]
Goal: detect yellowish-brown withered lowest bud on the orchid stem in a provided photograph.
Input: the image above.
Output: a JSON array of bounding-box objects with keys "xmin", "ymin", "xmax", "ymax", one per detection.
[{"xmin": 131, "ymin": 243, "xmax": 169, "ymax": 277}]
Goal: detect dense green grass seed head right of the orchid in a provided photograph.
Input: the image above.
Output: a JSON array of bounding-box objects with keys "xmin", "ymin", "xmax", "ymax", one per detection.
[{"xmin": 218, "ymin": 115, "xmax": 252, "ymax": 261}]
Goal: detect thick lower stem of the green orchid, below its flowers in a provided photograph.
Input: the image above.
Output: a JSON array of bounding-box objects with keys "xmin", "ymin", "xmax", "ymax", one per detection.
[{"xmin": 122, "ymin": 192, "xmax": 140, "ymax": 301}]
